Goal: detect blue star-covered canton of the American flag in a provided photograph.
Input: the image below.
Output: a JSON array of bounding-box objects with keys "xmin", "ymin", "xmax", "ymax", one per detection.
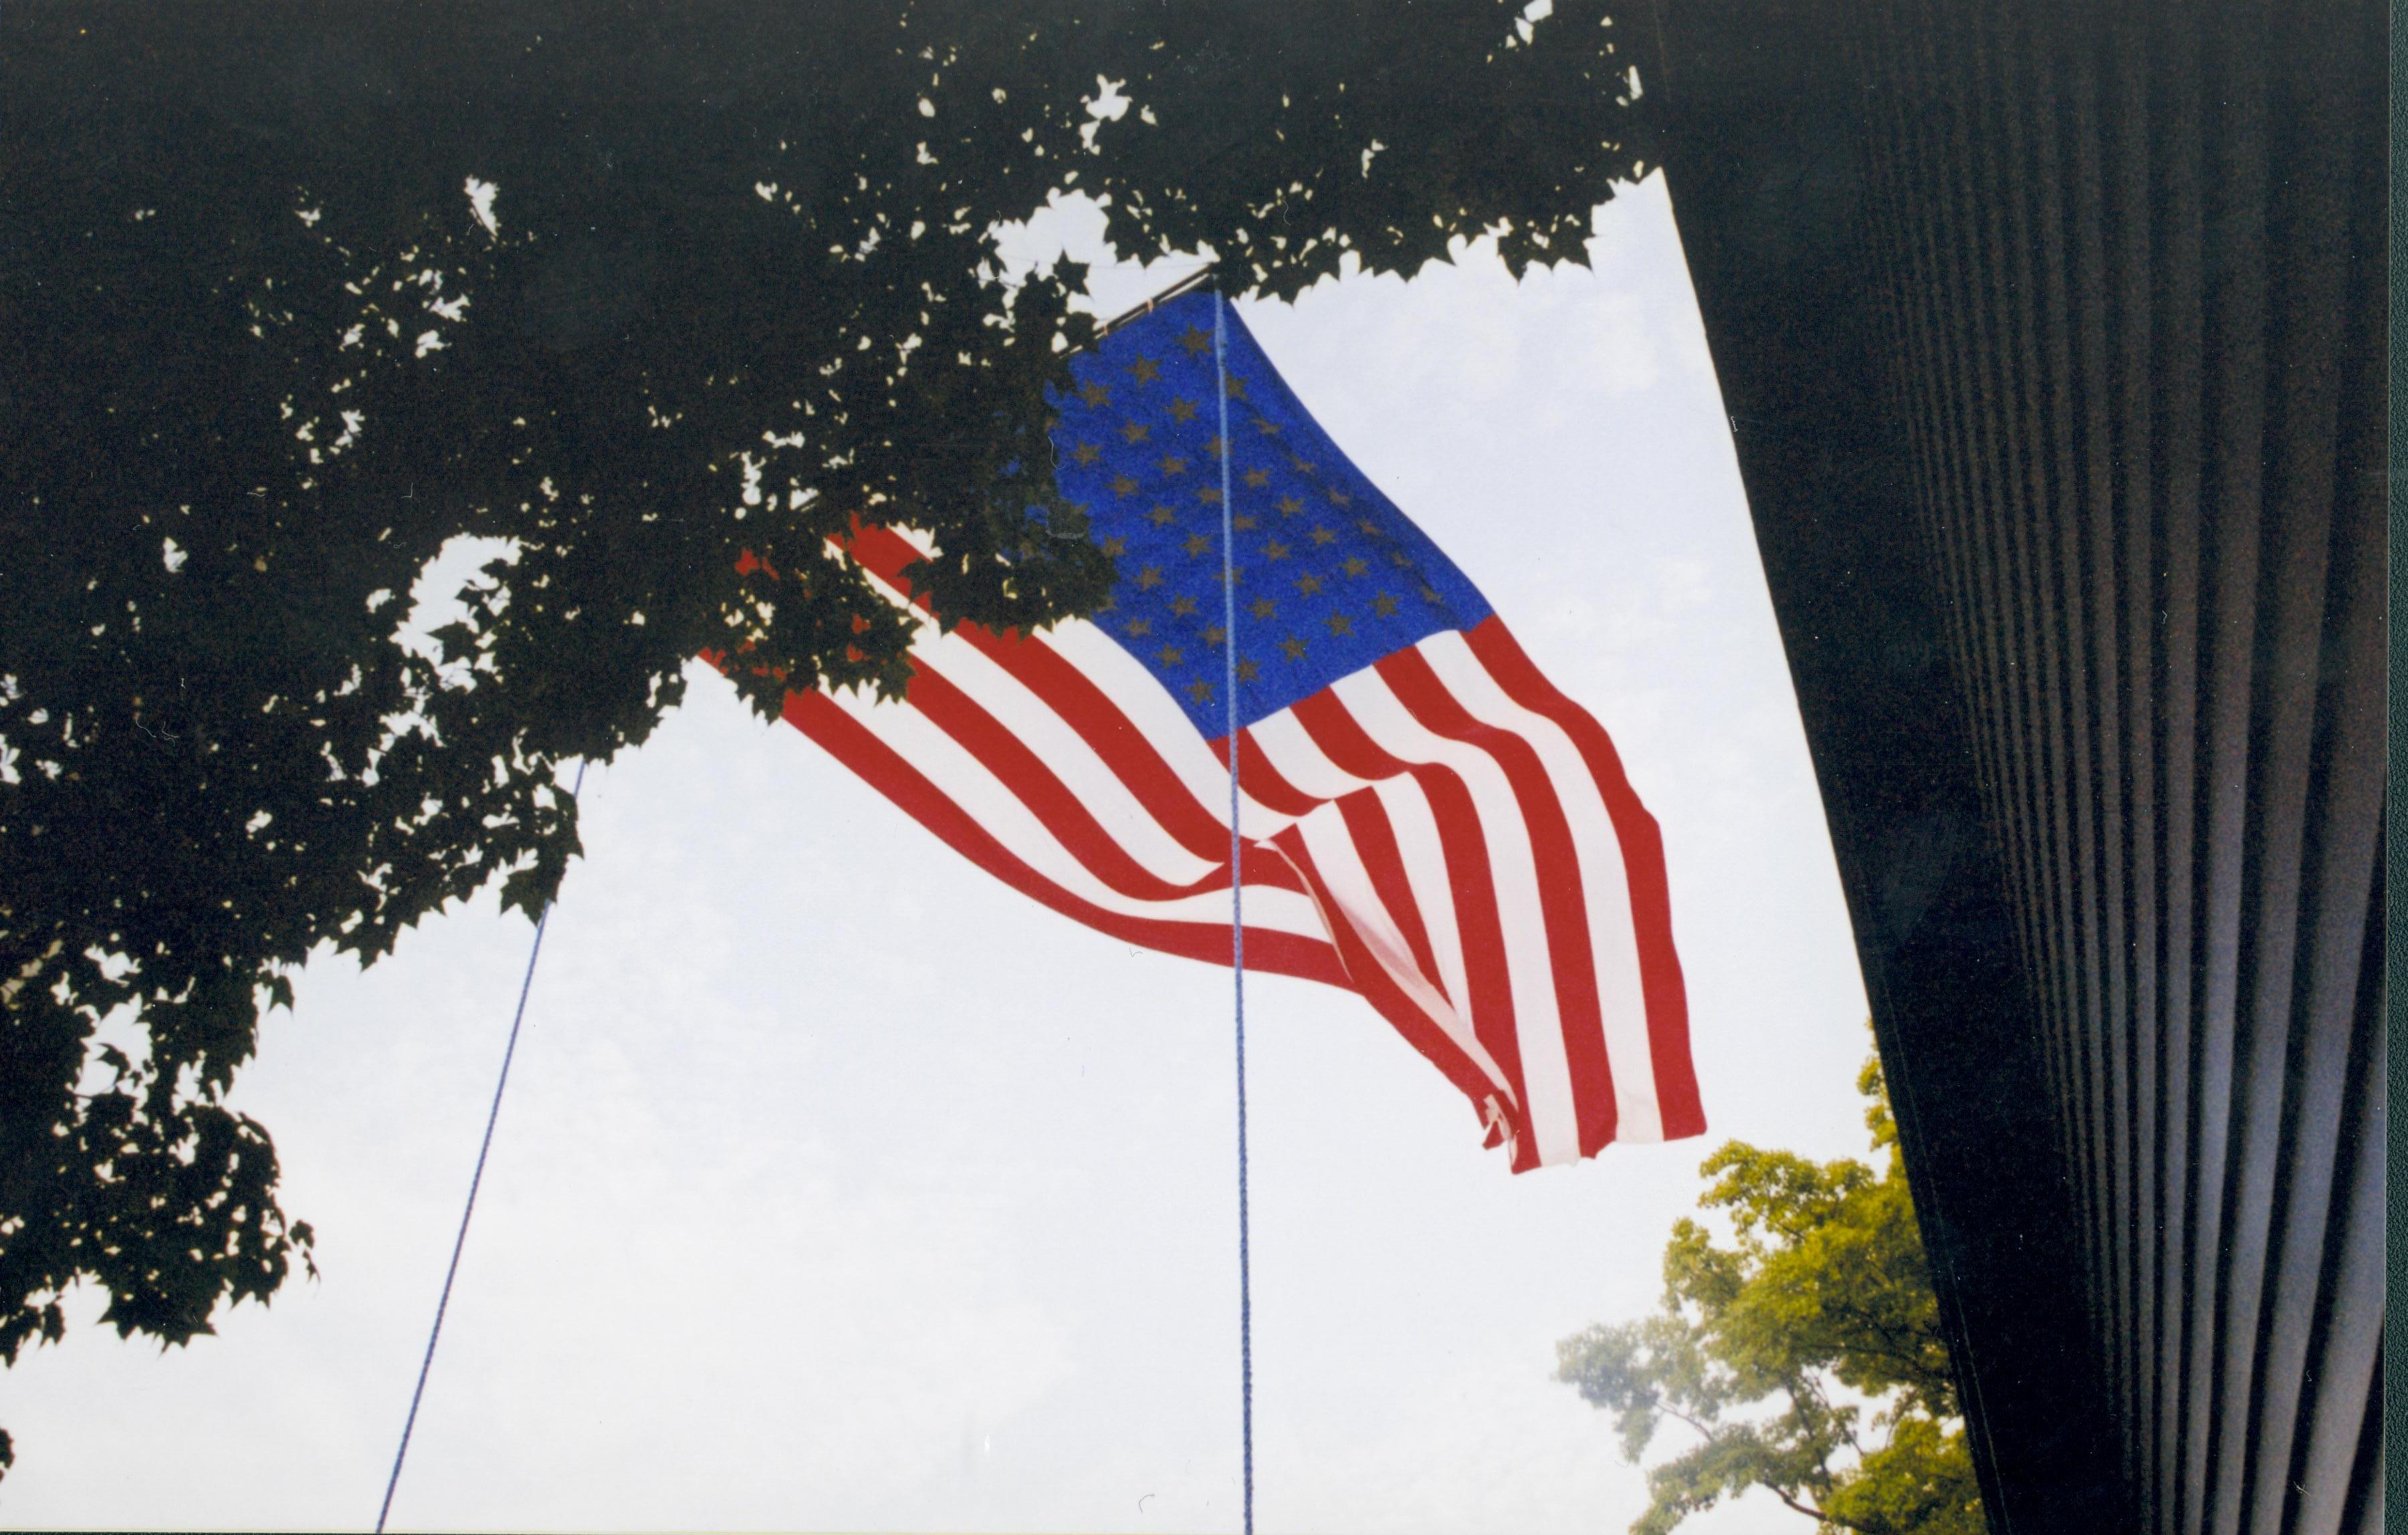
[{"xmin": 1053, "ymin": 293, "xmax": 1488, "ymax": 739}]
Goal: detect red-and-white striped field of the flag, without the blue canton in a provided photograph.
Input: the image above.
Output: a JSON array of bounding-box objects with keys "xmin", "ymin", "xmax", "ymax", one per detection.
[{"xmin": 797, "ymin": 529, "xmax": 1695, "ymax": 1167}]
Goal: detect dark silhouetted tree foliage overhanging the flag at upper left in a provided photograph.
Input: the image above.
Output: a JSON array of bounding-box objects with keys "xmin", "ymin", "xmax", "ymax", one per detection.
[{"xmin": 0, "ymin": 0, "xmax": 1644, "ymax": 1465}]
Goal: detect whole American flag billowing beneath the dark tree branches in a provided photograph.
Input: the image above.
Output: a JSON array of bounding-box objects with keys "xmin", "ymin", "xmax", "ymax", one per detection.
[{"xmin": 785, "ymin": 293, "xmax": 1705, "ymax": 1172}]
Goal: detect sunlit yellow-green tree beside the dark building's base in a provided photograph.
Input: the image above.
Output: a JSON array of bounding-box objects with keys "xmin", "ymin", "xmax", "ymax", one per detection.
[{"xmin": 1555, "ymin": 1061, "xmax": 1987, "ymax": 1535}]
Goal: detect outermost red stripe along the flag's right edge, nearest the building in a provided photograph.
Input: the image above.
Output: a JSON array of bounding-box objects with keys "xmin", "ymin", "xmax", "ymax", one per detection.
[{"xmin": 1464, "ymin": 616, "xmax": 1705, "ymax": 1141}]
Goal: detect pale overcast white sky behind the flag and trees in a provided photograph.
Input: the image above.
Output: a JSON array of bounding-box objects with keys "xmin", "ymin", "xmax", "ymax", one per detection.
[{"xmin": 0, "ymin": 178, "xmax": 1871, "ymax": 1532}]
